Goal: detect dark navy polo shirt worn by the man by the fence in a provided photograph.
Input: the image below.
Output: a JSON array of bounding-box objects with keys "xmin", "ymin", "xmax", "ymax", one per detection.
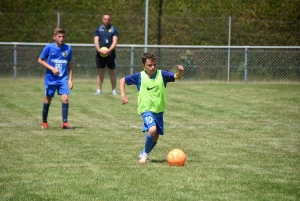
[{"xmin": 94, "ymin": 25, "xmax": 119, "ymax": 54}]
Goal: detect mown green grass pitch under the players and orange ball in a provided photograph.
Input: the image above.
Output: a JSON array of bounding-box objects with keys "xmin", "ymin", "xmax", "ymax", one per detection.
[{"xmin": 0, "ymin": 79, "xmax": 300, "ymax": 201}]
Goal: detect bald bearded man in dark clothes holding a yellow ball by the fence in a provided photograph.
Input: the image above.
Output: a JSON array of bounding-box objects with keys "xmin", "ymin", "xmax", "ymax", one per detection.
[{"xmin": 94, "ymin": 14, "xmax": 119, "ymax": 95}]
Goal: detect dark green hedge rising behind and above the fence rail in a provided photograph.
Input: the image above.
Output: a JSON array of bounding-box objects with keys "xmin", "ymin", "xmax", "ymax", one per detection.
[{"xmin": 0, "ymin": 0, "xmax": 300, "ymax": 46}]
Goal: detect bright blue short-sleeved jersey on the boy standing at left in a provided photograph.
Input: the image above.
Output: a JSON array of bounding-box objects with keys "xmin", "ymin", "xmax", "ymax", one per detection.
[{"xmin": 40, "ymin": 42, "xmax": 72, "ymax": 85}]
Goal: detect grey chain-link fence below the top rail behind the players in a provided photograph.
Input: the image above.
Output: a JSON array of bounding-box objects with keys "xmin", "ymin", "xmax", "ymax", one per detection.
[{"xmin": 0, "ymin": 42, "xmax": 300, "ymax": 82}]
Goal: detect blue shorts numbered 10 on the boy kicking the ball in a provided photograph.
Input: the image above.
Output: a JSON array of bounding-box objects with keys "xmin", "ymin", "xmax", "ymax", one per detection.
[{"xmin": 142, "ymin": 112, "xmax": 164, "ymax": 135}]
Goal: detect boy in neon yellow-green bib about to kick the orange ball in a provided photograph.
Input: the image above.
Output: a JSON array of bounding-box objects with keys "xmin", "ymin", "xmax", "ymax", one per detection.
[{"xmin": 120, "ymin": 52, "xmax": 184, "ymax": 164}]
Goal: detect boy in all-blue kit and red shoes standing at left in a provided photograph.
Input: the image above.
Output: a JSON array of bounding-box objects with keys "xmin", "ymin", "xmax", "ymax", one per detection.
[{"xmin": 38, "ymin": 27, "xmax": 73, "ymax": 129}]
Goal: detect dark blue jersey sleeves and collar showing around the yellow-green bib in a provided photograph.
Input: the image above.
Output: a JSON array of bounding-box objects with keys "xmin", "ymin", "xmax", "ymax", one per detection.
[{"xmin": 125, "ymin": 70, "xmax": 175, "ymax": 91}]
